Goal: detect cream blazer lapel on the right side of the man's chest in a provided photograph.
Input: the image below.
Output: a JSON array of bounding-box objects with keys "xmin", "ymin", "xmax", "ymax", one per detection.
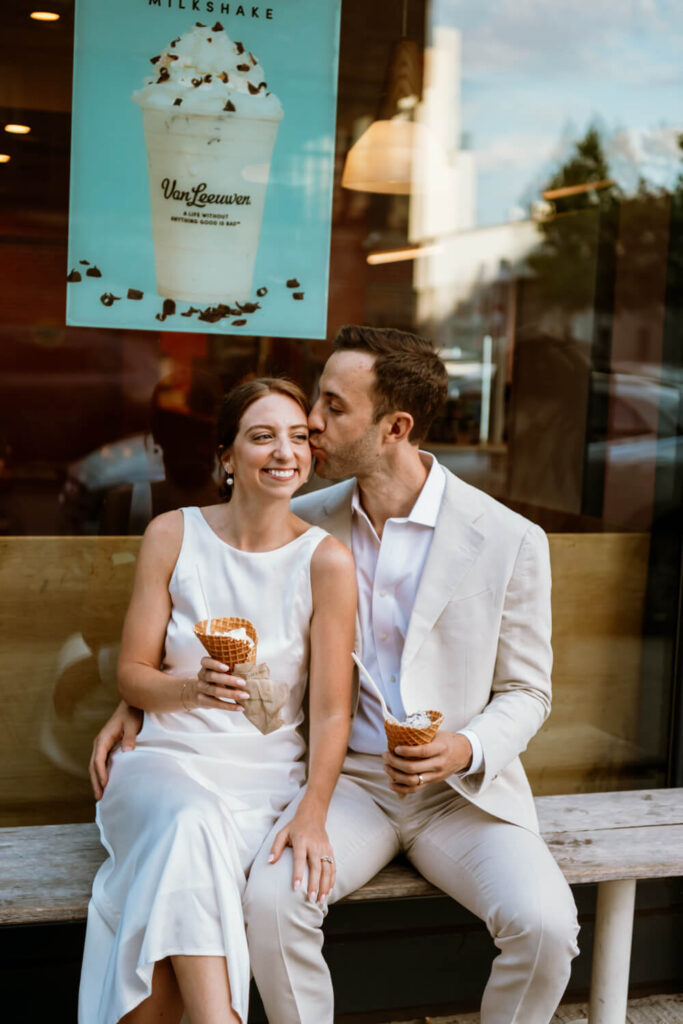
[{"xmin": 400, "ymin": 471, "xmax": 484, "ymax": 675}]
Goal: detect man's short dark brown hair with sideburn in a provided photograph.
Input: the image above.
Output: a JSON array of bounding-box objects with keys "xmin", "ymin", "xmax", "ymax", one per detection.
[{"xmin": 334, "ymin": 326, "xmax": 449, "ymax": 444}]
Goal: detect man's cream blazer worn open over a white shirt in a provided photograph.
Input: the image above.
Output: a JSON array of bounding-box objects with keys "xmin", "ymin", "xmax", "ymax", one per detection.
[{"xmin": 292, "ymin": 470, "xmax": 553, "ymax": 831}]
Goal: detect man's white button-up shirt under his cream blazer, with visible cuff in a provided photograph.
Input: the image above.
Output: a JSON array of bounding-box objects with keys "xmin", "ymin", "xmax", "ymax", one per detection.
[{"xmin": 349, "ymin": 452, "xmax": 483, "ymax": 775}]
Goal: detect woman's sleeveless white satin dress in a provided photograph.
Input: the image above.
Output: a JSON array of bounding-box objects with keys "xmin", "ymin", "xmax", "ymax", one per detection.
[{"xmin": 79, "ymin": 508, "xmax": 327, "ymax": 1024}]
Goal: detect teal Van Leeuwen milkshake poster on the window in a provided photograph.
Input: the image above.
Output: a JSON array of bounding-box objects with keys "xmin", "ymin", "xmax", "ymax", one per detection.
[{"xmin": 67, "ymin": 0, "xmax": 341, "ymax": 338}]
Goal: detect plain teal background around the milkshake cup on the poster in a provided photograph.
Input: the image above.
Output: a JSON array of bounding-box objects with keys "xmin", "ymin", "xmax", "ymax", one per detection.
[{"xmin": 67, "ymin": 0, "xmax": 341, "ymax": 338}]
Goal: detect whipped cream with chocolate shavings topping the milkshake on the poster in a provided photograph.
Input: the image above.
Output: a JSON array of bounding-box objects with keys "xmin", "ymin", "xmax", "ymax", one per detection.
[{"xmin": 133, "ymin": 22, "xmax": 284, "ymax": 121}]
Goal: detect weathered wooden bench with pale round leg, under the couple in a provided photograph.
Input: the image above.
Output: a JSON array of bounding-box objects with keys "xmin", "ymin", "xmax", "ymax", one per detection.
[{"xmin": 0, "ymin": 790, "xmax": 683, "ymax": 1024}]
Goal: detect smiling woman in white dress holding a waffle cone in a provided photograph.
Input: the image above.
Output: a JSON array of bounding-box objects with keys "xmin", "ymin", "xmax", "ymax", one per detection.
[{"xmin": 79, "ymin": 379, "xmax": 356, "ymax": 1024}]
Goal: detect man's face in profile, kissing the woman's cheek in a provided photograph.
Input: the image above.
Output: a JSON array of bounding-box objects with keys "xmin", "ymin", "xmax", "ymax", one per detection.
[{"xmin": 308, "ymin": 350, "xmax": 381, "ymax": 480}]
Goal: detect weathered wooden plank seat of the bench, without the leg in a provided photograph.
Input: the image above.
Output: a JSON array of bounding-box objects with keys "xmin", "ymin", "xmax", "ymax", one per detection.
[{"xmin": 0, "ymin": 790, "xmax": 683, "ymax": 925}]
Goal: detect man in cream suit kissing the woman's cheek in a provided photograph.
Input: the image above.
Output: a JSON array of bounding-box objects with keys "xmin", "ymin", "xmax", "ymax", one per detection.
[{"xmin": 91, "ymin": 327, "xmax": 578, "ymax": 1024}]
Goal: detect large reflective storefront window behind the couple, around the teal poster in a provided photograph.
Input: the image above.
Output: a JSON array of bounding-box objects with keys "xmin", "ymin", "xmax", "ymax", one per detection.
[{"xmin": 0, "ymin": 0, "xmax": 683, "ymax": 824}]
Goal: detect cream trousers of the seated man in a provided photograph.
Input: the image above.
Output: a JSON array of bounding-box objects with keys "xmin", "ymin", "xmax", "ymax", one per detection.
[{"xmin": 245, "ymin": 754, "xmax": 579, "ymax": 1024}]
